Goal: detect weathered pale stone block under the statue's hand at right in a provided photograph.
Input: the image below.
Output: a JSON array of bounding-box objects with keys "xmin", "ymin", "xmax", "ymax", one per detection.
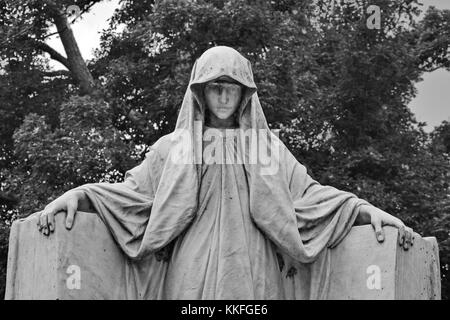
[{"xmin": 328, "ymin": 226, "xmax": 441, "ymax": 300}]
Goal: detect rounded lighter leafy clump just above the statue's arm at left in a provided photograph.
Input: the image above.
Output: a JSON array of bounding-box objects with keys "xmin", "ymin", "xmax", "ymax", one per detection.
[{"xmin": 6, "ymin": 96, "xmax": 139, "ymax": 214}]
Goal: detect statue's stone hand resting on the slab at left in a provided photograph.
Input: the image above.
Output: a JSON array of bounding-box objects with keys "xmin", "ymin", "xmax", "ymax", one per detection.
[{"xmin": 37, "ymin": 190, "xmax": 80, "ymax": 236}]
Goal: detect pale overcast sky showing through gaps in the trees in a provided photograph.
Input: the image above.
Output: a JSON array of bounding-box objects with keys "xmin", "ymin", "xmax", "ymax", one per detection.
[{"xmin": 48, "ymin": 0, "xmax": 450, "ymax": 131}]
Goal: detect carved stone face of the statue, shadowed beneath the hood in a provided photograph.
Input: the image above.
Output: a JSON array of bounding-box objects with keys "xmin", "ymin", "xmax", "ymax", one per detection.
[{"xmin": 205, "ymin": 77, "xmax": 242, "ymax": 120}]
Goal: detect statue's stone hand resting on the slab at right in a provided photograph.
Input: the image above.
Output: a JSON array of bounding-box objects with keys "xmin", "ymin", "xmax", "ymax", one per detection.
[{"xmin": 357, "ymin": 205, "xmax": 414, "ymax": 250}]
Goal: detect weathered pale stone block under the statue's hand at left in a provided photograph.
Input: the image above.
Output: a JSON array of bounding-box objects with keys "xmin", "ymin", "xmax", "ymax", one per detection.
[{"xmin": 5, "ymin": 212, "xmax": 125, "ymax": 299}]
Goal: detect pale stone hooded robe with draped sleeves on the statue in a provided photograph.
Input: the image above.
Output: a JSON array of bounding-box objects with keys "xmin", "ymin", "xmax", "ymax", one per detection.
[{"xmin": 71, "ymin": 47, "xmax": 367, "ymax": 299}]
